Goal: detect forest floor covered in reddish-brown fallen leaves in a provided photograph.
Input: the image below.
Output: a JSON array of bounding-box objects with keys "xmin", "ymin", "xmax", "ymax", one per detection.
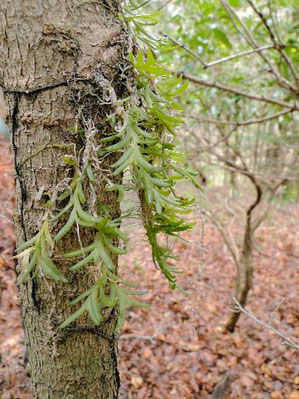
[{"xmin": 0, "ymin": 139, "xmax": 299, "ymax": 399}]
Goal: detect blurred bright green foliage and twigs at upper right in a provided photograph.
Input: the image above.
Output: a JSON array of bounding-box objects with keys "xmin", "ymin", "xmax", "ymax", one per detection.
[{"xmin": 159, "ymin": 0, "xmax": 299, "ymax": 192}]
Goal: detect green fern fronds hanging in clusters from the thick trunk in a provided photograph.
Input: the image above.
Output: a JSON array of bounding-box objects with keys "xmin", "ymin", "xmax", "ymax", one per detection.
[{"xmin": 15, "ymin": 0, "xmax": 200, "ymax": 331}]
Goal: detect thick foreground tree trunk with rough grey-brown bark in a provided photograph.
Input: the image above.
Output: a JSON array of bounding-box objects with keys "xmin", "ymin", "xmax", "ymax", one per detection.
[{"xmin": 0, "ymin": 0, "xmax": 128, "ymax": 399}]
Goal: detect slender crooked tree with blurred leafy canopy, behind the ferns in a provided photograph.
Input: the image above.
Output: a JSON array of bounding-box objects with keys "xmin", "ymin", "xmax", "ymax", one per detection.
[{"xmin": 158, "ymin": 0, "xmax": 299, "ymax": 331}]
